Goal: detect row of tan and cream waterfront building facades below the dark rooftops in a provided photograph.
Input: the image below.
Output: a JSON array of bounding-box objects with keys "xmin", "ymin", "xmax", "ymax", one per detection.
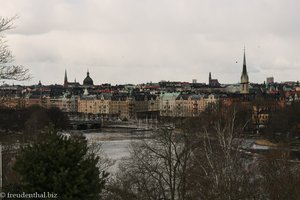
[{"xmin": 1, "ymin": 92, "xmax": 219, "ymax": 119}]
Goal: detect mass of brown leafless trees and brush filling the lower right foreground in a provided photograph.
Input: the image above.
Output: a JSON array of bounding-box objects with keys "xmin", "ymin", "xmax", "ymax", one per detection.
[{"xmin": 104, "ymin": 108, "xmax": 300, "ymax": 200}]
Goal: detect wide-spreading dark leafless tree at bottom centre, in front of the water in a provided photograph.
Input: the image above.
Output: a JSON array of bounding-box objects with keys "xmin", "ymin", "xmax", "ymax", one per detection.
[{"xmin": 105, "ymin": 128, "xmax": 191, "ymax": 200}]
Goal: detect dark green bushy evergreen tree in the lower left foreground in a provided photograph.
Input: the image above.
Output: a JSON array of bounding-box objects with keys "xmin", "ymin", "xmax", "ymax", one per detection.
[{"xmin": 15, "ymin": 128, "xmax": 108, "ymax": 200}]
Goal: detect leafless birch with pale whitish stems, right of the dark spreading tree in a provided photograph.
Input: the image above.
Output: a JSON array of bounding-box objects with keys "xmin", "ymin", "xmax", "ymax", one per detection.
[{"xmin": 189, "ymin": 109, "xmax": 258, "ymax": 200}]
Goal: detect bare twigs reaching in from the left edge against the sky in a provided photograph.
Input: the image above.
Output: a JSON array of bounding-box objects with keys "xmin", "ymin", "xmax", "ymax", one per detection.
[{"xmin": 0, "ymin": 16, "xmax": 30, "ymax": 81}]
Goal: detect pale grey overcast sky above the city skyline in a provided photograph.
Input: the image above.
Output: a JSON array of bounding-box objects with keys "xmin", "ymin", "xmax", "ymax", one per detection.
[{"xmin": 0, "ymin": 0, "xmax": 300, "ymax": 85}]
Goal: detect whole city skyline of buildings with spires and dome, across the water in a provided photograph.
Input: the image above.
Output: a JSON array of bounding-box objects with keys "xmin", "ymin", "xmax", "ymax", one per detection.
[{"xmin": 0, "ymin": 52, "xmax": 300, "ymax": 122}]
